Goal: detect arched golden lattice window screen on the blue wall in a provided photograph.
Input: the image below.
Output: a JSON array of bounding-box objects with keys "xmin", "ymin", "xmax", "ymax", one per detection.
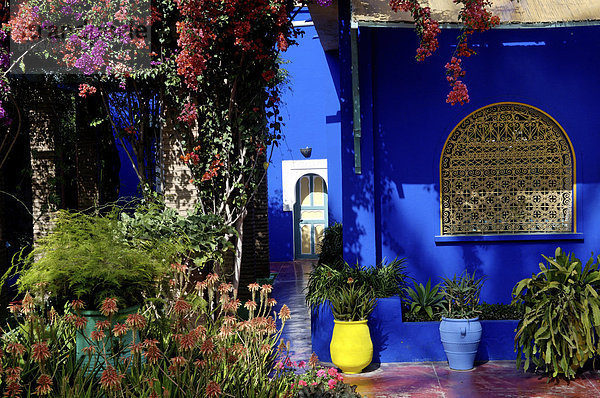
[{"xmin": 440, "ymin": 103, "xmax": 575, "ymax": 235}]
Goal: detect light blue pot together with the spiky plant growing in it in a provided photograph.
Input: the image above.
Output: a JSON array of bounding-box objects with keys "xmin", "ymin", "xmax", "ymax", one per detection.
[{"xmin": 440, "ymin": 271, "xmax": 485, "ymax": 370}]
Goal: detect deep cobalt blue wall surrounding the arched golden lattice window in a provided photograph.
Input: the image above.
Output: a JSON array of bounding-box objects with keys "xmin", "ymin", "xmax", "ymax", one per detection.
[{"xmin": 344, "ymin": 27, "xmax": 600, "ymax": 303}]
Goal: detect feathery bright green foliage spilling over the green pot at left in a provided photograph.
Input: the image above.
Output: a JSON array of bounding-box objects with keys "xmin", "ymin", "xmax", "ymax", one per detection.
[{"xmin": 17, "ymin": 211, "xmax": 171, "ymax": 368}]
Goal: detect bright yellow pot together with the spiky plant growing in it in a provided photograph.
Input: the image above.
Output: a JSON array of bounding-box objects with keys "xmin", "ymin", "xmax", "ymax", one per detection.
[{"xmin": 329, "ymin": 278, "xmax": 377, "ymax": 374}]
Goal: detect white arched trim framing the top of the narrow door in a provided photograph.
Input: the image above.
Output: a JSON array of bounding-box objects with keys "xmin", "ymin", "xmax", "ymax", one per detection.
[{"xmin": 281, "ymin": 159, "xmax": 329, "ymax": 211}]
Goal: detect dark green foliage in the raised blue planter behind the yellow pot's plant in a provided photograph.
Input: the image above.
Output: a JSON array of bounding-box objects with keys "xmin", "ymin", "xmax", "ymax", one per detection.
[{"xmin": 305, "ymin": 258, "xmax": 408, "ymax": 308}]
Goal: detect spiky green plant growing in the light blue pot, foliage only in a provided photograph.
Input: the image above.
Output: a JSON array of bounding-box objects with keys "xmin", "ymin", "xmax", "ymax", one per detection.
[{"xmin": 442, "ymin": 270, "xmax": 485, "ymax": 319}]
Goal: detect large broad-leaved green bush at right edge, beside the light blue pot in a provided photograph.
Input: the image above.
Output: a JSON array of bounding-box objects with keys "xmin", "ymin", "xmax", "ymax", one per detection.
[{"xmin": 512, "ymin": 247, "xmax": 600, "ymax": 379}]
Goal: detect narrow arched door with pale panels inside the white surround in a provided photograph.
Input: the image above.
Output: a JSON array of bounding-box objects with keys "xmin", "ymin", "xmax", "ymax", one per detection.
[{"xmin": 294, "ymin": 174, "xmax": 328, "ymax": 259}]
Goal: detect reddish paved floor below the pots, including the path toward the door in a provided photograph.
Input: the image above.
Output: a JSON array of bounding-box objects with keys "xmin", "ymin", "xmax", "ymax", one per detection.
[{"xmin": 271, "ymin": 261, "xmax": 600, "ymax": 398}]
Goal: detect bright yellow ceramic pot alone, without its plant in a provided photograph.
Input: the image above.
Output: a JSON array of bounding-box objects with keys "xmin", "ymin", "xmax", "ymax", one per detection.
[{"xmin": 329, "ymin": 320, "xmax": 373, "ymax": 374}]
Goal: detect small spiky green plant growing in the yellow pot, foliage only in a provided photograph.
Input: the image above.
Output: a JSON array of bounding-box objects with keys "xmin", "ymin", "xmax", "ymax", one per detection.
[{"xmin": 329, "ymin": 278, "xmax": 377, "ymax": 322}]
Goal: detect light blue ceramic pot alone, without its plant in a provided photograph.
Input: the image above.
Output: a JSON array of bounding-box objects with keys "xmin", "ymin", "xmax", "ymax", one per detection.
[{"xmin": 440, "ymin": 317, "xmax": 481, "ymax": 370}]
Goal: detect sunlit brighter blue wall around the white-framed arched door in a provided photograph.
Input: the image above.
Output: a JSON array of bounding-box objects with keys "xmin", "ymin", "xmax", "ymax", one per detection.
[{"xmin": 268, "ymin": 8, "xmax": 342, "ymax": 261}]
